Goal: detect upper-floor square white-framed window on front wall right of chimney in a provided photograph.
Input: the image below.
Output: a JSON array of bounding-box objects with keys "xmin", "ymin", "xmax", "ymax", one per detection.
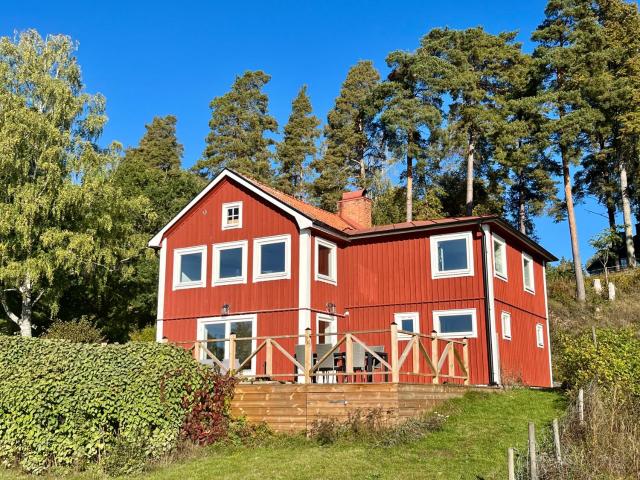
[{"xmin": 430, "ymin": 232, "xmax": 473, "ymax": 278}]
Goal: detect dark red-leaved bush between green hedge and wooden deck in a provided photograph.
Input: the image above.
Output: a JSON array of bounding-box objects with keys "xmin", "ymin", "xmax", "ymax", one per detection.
[{"xmin": 180, "ymin": 368, "xmax": 237, "ymax": 445}]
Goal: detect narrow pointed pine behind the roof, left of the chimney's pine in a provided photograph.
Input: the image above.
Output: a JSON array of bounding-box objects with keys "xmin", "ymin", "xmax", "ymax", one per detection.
[{"xmin": 277, "ymin": 86, "xmax": 320, "ymax": 198}]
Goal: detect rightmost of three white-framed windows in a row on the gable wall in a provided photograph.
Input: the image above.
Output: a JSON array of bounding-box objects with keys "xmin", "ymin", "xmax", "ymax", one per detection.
[{"xmin": 253, "ymin": 235, "xmax": 291, "ymax": 282}]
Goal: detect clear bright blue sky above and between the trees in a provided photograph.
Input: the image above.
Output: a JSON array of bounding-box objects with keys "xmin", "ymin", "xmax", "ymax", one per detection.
[{"xmin": 0, "ymin": 0, "xmax": 620, "ymax": 260}]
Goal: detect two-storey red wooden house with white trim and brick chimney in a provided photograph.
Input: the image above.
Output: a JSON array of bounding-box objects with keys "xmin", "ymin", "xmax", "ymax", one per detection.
[{"xmin": 149, "ymin": 170, "xmax": 555, "ymax": 386}]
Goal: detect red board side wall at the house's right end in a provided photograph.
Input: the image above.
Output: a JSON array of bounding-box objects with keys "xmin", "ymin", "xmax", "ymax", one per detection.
[{"xmin": 492, "ymin": 227, "xmax": 551, "ymax": 387}]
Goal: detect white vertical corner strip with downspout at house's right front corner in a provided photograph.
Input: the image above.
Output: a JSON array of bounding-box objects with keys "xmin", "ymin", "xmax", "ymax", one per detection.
[{"xmin": 480, "ymin": 224, "xmax": 501, "ymax": 385}]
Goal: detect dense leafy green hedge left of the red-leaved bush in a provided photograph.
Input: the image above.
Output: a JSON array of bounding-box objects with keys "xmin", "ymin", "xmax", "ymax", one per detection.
[{"xmin": 0, "ymin": 336, "xmax": 202, "ymax": 473}]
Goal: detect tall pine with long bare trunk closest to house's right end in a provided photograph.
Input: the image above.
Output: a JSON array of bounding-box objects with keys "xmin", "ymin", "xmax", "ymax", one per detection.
[{"xmin": 532, "ymin": 0, "xmax": 594, "ymax": 302}]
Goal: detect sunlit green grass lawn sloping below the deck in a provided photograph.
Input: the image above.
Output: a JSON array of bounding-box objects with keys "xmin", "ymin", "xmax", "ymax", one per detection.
[{"xmin": 0, "ymin": 389, "xmax": 565, "ymax": 480}]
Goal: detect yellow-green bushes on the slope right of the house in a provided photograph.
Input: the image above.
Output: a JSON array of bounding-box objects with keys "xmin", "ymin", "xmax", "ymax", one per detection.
[{"xmin": 559, "ymin": 328, "xmax": 640, "ymax": 395}]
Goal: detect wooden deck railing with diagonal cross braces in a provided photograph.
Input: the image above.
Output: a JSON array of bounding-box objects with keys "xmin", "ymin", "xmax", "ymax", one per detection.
[{"xmin": 176, "ymin": 323, "xmax": 470, "ymax": 385}]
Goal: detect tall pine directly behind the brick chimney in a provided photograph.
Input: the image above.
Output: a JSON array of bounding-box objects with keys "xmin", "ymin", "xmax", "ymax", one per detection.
[{"xmin": 311, "ymin": 61, "xmax": 384, "ymax": 211}]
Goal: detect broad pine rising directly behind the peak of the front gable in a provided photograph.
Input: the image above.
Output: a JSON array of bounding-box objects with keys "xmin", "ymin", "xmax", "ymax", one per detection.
[{"xmin": 194, "ymin": 71, "xmax": 278, "ymax": 183}]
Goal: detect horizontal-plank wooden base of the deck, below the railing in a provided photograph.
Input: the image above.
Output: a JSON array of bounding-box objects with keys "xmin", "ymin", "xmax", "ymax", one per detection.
[{"xmin": 231, "ymin": 383, "xmax": 496, "ymax": 432}]
